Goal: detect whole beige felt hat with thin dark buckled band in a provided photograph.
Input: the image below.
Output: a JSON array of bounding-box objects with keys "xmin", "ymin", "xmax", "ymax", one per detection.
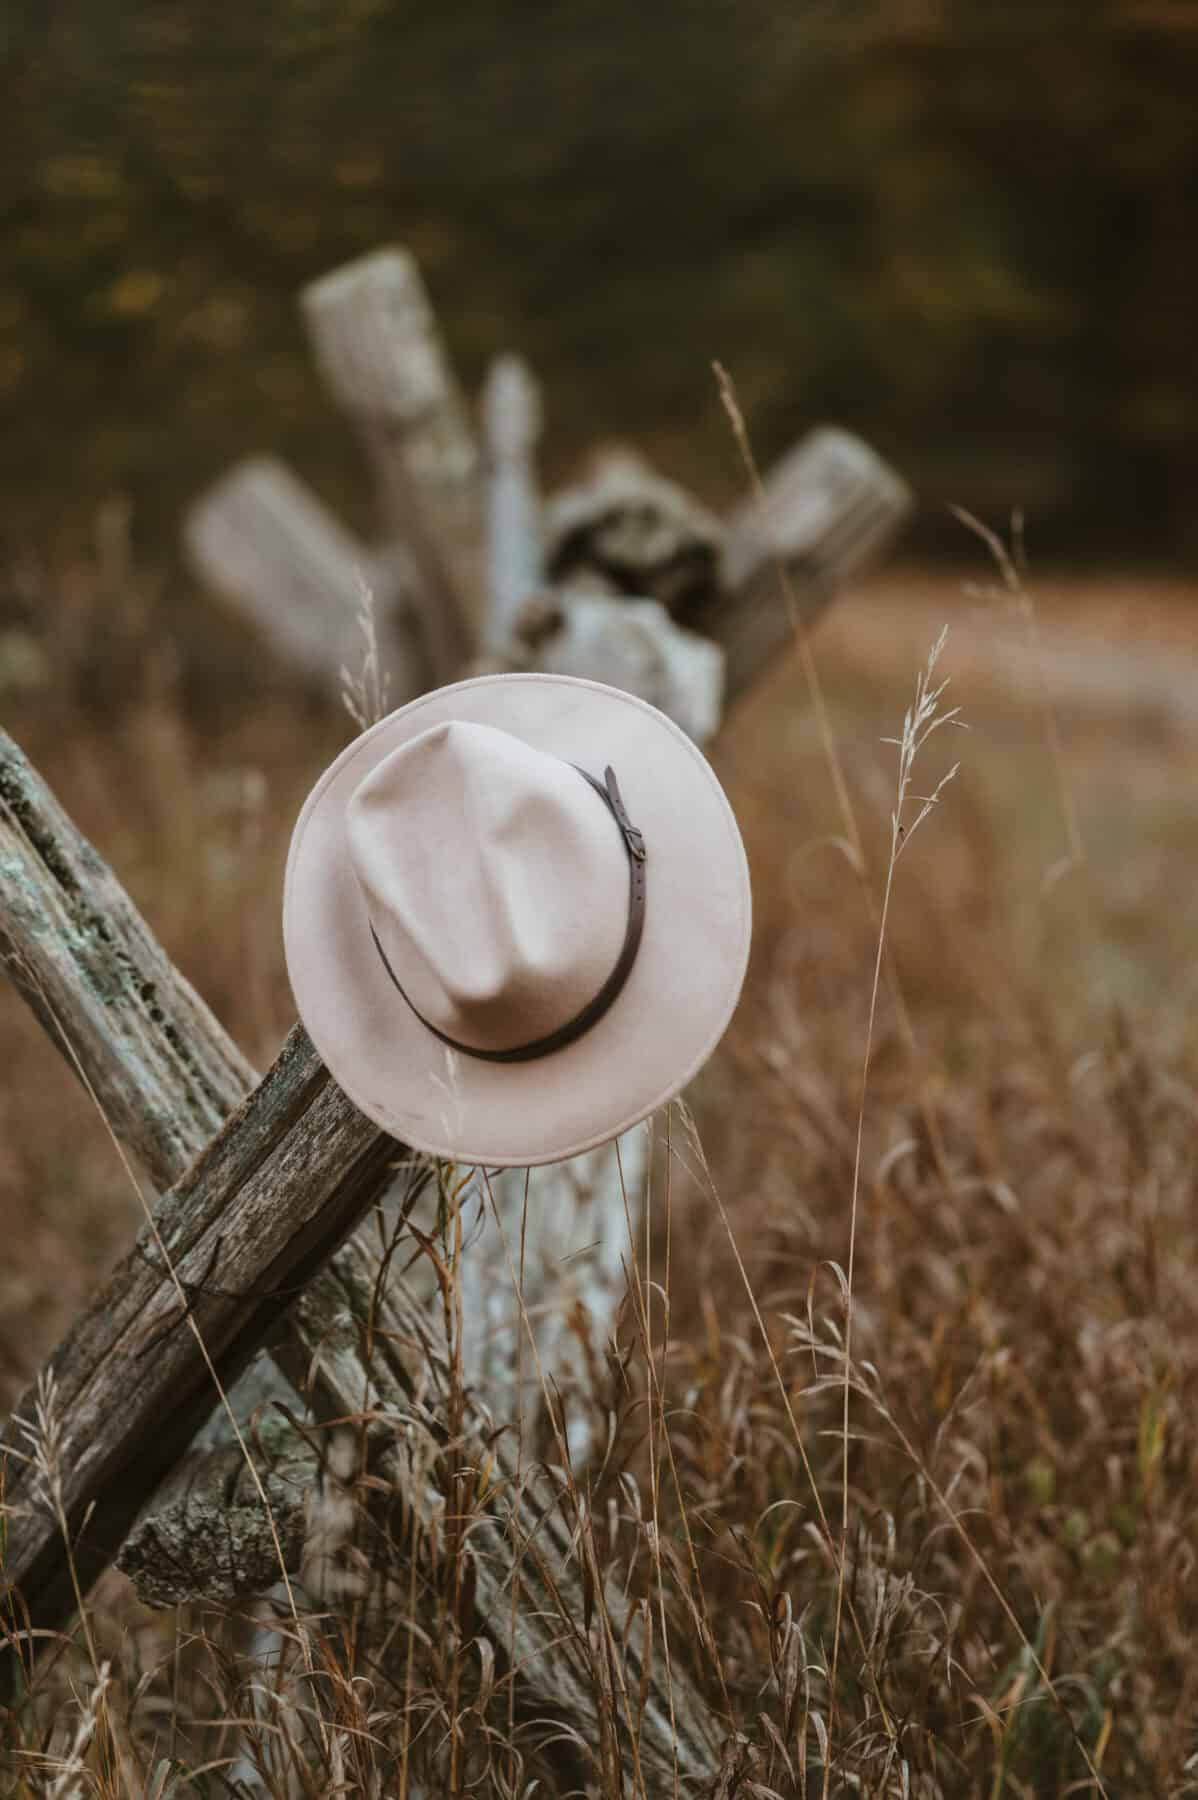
[{"xmin": 282, "ymin": 675, "xmax": 750, "ymax": 1166}]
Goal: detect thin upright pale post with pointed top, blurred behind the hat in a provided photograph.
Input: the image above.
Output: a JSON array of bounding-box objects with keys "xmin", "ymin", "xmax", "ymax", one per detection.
[{"xmin": 482, "ymin": 356, "xmax": 543, "ymax": 655}]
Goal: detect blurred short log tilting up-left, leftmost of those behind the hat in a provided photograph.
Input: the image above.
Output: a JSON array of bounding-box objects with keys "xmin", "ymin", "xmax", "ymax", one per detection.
[{"xmin": 183, "ymin": 457, "xmax": 425, "ymax": 700}]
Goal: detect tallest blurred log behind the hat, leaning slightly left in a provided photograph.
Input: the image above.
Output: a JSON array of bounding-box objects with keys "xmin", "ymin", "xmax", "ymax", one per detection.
[{"xmin": 300, "ymin": 248, "xmax": 482, "ymax": 686}]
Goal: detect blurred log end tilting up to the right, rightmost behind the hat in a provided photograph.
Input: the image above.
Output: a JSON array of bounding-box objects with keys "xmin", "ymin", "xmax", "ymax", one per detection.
[{"xmin": 705, "ymin": 427, "xmax": 912, "ymax": 695}]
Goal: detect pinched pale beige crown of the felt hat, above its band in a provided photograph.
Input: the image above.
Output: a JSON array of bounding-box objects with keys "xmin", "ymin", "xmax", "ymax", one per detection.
[{"xmin": 347, "ymin": 720, "xmax": 628, "ymax": 1051}]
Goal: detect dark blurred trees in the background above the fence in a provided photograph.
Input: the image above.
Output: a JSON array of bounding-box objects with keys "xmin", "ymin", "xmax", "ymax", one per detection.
[{"xmin": 0, "ymin": 0, "xmax": 1198, "ymax": 554}]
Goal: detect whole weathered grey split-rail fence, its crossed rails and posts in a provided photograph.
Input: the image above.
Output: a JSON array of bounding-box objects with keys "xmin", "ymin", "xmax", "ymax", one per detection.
[{"xmin": 0, "ymin": 250, "xmax": 910, "ymax": 1793}]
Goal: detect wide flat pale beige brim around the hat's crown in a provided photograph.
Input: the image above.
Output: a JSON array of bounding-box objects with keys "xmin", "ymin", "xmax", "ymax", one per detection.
[{"xmin": 282, "ymin": 675, "xmax": 752, "ymax": 1168}]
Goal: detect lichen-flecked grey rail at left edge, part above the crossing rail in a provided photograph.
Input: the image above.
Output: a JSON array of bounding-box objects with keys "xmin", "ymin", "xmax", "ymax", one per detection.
[{"xmin": 0, "ymin": 733, "xmax": 255, "ymax": 1186}]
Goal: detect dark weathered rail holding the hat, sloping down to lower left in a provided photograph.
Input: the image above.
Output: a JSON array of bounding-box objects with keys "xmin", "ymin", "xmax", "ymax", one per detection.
[{"xmin": 0, "ymin": 1026, "xmax": 401, "ymax": 1648}]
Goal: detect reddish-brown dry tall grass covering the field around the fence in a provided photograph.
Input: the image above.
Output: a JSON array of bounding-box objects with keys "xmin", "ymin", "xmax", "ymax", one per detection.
[{"xmin": 0, "ymin": 536, "xmax": 1198, "ymax": 1800}]
